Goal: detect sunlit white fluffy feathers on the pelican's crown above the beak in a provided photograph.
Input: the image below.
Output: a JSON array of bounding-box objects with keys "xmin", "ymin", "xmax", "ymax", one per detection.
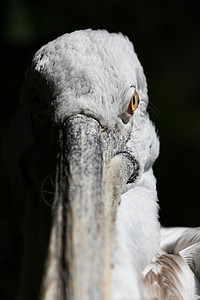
[{"xmin": 32, "ymin": 30, "xmax": 147, "ymax": 127}]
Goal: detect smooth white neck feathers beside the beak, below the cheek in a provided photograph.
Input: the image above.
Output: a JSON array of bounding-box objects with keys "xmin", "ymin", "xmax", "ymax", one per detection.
[{"xmin": 112, "ymin": 169, "xmax": 160, "ymax": 300}]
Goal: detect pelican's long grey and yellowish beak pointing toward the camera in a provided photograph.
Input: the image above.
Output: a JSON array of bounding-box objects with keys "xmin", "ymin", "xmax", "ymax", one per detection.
[{"xmin": 41, "ymin": 115, "xmax": 134, "ymax": 300}]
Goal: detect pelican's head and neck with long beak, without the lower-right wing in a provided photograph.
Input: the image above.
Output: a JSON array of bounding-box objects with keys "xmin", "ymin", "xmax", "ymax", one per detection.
[{"xmin": 4, "ymin": 30, "xmax": 200, "ymax": 300}]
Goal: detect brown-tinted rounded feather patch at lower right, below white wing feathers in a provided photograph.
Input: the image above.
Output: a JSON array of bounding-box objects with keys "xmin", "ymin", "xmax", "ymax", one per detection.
[{"xmin": 142, "ymin": 254, "xmax": 197, "ymax": 300}]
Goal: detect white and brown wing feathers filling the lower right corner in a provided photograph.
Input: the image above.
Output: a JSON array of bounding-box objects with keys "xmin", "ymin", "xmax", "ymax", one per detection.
[{"xmin": 142, "ymin": 227, "xmax": 200, "ymax": 300}]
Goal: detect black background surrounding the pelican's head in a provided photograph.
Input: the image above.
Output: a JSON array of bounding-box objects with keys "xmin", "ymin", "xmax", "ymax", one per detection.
[{"xmin": 0, "ymin": 0, "xmax": 200, "ymax": 226}]
